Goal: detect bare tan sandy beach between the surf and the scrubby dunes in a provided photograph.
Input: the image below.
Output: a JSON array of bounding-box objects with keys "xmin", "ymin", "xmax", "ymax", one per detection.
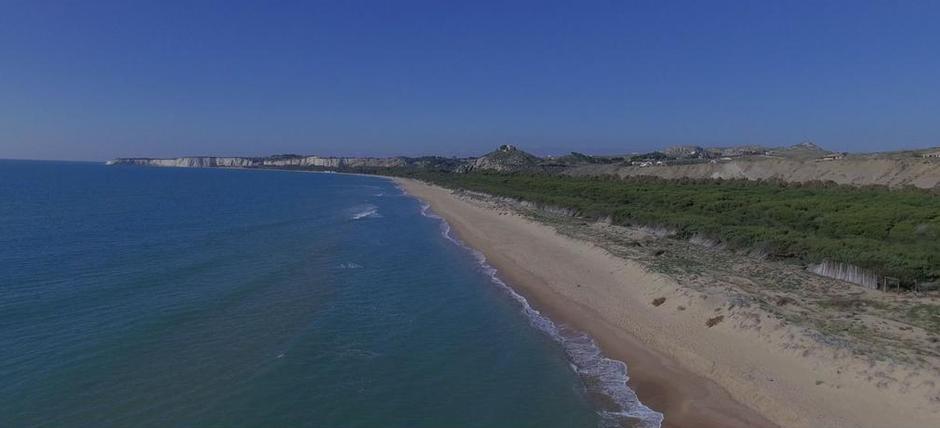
[{"xmin": 396, "ymin": 179, "xmax": 940, "ymax": 427}]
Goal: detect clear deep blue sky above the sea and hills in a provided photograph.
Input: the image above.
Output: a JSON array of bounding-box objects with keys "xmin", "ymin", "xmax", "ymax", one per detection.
[{"xmin": 0, "ymin": 0, "xmax": 940, "ymax": 159}]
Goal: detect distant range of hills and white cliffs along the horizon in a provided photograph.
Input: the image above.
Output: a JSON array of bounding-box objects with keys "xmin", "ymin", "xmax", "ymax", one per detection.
[{"xmin": 108, "ymin": 142, "xmax": 940, "ymax": 189}]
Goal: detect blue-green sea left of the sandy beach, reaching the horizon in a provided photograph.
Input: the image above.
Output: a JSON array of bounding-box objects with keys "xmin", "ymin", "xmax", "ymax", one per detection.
[{"xmin": 0, "ymin": 161, "xmax": 661, "ymax": 427}]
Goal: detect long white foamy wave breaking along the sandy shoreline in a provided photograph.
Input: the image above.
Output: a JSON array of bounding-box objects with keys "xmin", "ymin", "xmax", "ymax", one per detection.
[{"xmin": 421, "ymin": 203, "xmax": 663, "ymax": 428}]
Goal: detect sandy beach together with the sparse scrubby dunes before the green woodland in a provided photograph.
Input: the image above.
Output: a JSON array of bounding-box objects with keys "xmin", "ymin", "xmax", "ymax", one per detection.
[{"xmin": 400, "ymin": 180, "xmax": 940, "ymax": 427}]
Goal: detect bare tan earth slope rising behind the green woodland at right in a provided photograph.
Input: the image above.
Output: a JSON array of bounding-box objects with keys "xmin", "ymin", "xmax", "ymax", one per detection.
[{"xmin": 565, "ymin": 156, "xmax": 940, "ymax": 188}]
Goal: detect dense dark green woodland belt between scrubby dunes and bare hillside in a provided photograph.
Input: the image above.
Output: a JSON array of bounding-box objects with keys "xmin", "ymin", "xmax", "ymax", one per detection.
[{"xmin": 383, "ymin": 169, "xmax": 940, "ymax": 286}]
